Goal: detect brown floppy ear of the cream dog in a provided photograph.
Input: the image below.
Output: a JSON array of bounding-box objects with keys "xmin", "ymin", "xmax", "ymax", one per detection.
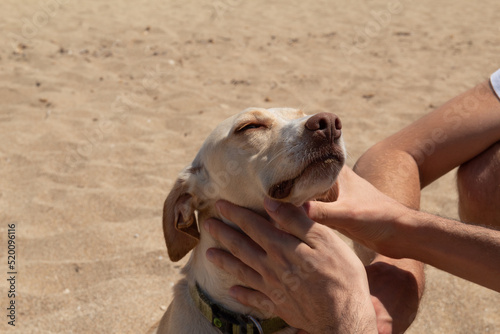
[{"xmin": 163, "ymin": 172, "xmax": 200, "ymax": 262}]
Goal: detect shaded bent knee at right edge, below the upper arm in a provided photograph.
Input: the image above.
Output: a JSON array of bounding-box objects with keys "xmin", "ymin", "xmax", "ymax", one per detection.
[{"xmin": 457, "ymin": 142, "xmax": 500, "ymax": 226}]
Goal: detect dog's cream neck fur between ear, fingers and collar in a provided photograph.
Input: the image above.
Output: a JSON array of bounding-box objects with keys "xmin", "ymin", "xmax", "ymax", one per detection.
[{"xmin": 184, "ymin": 206, "xmax": 270, "ymax": 319}]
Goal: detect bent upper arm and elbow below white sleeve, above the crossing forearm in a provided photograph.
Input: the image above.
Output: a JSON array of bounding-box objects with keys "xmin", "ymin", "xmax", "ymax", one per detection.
[{"xmin": 354, "ymin": 81, "xmax": 500, "ymax": 190}]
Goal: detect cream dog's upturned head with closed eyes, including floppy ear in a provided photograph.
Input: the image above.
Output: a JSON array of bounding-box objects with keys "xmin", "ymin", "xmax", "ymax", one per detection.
[{"xmin": 163, "ymin": 108, "xmax": 345, "ymax": 261}]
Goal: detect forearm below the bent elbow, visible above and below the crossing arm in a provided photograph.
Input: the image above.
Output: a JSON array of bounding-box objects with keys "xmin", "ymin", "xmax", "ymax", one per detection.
[{"xmin": 354, "ymin": 150, "xmax": 425, "ymax": 333}]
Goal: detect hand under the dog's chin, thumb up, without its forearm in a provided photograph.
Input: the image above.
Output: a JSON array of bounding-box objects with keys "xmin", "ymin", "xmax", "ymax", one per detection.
[{"xmin": 303, "ymin": 167, "xmax": 412, "ymax": 258}]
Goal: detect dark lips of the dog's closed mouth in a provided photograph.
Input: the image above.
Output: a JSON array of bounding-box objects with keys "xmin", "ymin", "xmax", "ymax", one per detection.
[{"xmin": 268, "ymin": 154, "xmax": 344, "ymax": 199}]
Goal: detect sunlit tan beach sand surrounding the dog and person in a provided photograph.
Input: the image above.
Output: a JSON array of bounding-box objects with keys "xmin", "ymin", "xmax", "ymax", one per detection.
[{"xmin": 0, "ymin": 0, "xmax": 500, "ymax": 333}]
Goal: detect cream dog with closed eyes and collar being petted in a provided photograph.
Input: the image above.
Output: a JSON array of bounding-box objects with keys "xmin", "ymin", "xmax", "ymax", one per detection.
[{"xmin": 156, "ymin": 108, "xmax": 345, "ymax": 334}]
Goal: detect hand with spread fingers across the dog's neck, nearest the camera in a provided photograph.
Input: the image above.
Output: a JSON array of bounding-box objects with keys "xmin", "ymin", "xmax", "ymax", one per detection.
[{"xmin": 204, "ymin": 200, "xmax": 376, "ymax": 333}]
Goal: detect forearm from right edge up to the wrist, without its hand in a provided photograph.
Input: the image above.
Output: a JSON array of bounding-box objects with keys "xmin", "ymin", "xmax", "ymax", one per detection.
[{"xmin": 394, "ymin": 210, "xmax": 500, "ymax": 292}]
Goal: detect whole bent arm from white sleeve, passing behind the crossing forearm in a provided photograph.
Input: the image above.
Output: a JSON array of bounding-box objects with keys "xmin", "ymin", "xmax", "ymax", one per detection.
[{"xmin": 344, "ymin": 76, "xmax": 500, "ymax": 332}]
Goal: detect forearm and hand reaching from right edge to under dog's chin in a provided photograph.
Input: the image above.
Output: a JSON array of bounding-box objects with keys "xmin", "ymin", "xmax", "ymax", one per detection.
[{"xmin": 304, "ymin": 169, "xmax": 500, "ymax": 292}]
